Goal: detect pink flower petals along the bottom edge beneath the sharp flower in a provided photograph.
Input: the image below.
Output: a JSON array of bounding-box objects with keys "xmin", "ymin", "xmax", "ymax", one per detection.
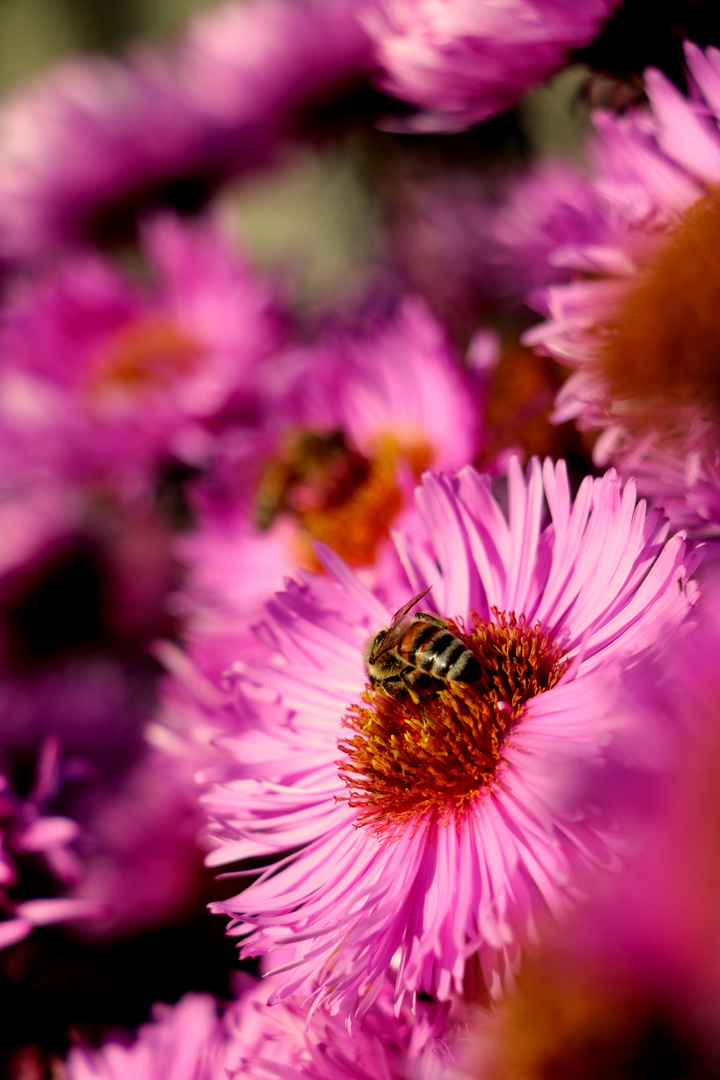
[{"xmin": 66, "ymin": 976, "xmax": 447, "ymax": 1080}]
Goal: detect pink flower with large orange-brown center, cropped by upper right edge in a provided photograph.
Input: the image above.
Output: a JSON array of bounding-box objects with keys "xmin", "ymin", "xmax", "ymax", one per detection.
[{"xmin": 526, "ymin": 44, "xmax": 720, "ymax": 535}]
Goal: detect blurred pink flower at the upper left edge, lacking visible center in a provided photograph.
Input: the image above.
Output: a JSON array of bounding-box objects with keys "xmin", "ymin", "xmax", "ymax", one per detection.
[{"xmin": 0, "ymin": 49, "xmax": 273, "ymax": 262}]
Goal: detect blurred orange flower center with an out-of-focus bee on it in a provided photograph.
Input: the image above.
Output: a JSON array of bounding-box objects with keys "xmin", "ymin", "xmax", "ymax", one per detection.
[{"xmin": 256, "ymin": 431, "xmax": 431, "ymax": 570}]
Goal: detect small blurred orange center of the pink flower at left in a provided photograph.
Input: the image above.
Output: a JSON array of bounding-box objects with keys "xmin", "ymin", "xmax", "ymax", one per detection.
[{"xmin": 90, "ymin": 316, "xmax": 202, "ymax": 401}]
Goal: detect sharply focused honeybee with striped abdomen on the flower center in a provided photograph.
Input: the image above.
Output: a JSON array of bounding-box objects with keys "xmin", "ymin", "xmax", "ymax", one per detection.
[{"xmin": 365, "ymin": 585, "xmax": 481, "ymax": 702}]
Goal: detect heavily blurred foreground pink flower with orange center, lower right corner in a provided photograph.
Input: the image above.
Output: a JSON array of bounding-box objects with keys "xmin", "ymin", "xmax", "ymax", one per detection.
[{"xmin": 453, "ymin": 587, "xmax": 720, "ymax": 1080}]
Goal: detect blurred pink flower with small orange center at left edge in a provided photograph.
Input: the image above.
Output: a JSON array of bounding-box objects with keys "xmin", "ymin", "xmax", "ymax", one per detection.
[{"xmin": 0, "ymin": 217, "xmax": 279, "ymax": 491}]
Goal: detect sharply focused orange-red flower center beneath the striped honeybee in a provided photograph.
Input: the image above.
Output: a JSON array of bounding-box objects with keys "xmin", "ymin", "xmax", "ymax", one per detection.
[{"xmin": 338, "ymin": 608, "xmax": 568, "ymax": 834}]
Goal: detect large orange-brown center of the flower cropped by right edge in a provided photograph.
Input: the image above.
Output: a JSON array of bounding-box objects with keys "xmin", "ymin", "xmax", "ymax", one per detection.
[{"xmin": 601, "ymin": 190, "xmax": 720, "ymax": 428}]
